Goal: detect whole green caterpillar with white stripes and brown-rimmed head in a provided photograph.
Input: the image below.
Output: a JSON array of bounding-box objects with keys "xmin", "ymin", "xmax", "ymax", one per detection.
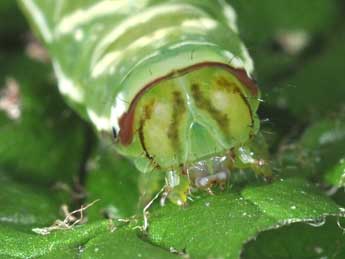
[{"xmin": 19, "ymin": 0, "xmax": 270, "ymax": 205}]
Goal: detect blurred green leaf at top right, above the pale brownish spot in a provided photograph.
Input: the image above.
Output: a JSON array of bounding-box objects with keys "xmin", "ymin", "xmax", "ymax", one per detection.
[{"xmin": 228, "ymin": 0, "xmax": 341, "ymax": 47}]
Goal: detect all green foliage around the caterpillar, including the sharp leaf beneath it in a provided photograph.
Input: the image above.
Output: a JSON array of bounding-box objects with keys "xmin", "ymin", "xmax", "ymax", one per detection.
[{"xmin": 0, "ymin": 0, "xmax": 345, "ymax": 259}]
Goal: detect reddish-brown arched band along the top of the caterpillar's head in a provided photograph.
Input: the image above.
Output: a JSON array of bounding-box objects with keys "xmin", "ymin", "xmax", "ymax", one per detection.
[{"xmin": 119, "ymin": 62, "xmax": 259, "ymax": 146}]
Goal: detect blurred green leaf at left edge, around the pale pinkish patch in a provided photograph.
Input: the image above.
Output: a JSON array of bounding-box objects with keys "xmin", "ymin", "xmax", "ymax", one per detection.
[{"xmin": 0, "ymin": 52, "xmax": 86, "ymax": 184}]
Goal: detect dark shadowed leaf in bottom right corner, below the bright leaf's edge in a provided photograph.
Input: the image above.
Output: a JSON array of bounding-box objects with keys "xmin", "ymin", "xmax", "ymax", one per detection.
[{"xmin": 243, "ymin": 218, "xmax": 345, "ymax": 259}]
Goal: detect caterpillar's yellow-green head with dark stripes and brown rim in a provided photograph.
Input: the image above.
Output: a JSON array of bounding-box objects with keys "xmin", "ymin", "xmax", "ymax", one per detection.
[{"xmin": 113, "ymin": 63, "xmax": 259, "ymax": 176}]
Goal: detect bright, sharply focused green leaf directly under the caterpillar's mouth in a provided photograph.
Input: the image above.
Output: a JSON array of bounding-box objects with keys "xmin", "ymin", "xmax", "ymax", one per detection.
[{"xmin": 149, "ymin": 179, "xmax": 341, "ymax": 259}]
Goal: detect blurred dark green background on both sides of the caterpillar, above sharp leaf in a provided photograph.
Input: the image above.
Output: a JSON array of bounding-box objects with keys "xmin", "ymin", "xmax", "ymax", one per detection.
[{"xmin": 0, "ymin": 0, "xmax": 345, "ymax": 258}]
